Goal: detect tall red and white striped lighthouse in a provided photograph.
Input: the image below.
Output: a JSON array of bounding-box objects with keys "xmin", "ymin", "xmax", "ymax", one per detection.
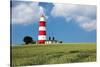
[{"xmin": 38, "ymin": 15, "xmax": 46, "ymax": 44}]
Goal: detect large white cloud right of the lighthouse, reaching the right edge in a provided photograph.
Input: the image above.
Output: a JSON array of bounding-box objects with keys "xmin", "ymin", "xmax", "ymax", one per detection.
[{"xmin": 51, "ymin": 4, "xmax": 96, "ymax": 31}]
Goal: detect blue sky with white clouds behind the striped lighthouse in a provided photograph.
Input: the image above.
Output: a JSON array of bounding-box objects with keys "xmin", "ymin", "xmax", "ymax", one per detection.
[{"xmin": 11, "ymin": 1, "xmax": 96, "ymax": 44}]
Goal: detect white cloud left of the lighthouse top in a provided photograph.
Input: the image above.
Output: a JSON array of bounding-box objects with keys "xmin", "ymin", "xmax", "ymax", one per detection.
[{"xmin": 12, "ymin": 2, "xmax": 43, "ymax": 24}]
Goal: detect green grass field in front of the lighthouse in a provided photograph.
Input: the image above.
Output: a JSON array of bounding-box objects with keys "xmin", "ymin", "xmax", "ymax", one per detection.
[{"xmin": 12, "ymin": 43, "xmax": 96, "ymax": 66}]
